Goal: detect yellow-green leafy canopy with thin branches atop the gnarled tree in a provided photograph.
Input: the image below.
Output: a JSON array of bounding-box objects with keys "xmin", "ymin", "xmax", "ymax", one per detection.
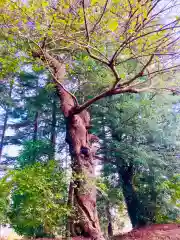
[{"xmin": 0, "ymin": 0, "xmax": 180, "ymax": 88}]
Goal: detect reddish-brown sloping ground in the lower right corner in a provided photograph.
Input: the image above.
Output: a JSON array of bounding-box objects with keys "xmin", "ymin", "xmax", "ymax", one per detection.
[{"xmin": 31, "ymin": 224, "xmax": 180, "ymax": 240}]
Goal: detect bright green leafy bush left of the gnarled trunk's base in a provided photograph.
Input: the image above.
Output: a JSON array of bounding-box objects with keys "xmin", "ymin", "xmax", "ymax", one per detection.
[{"xmin": 0, "ymin": 161, "xmax": 69, "ymax": 236}]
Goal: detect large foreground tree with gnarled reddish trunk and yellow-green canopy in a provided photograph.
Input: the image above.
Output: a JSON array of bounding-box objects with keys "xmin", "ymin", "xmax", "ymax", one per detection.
[{"xmin": 0, "ymin": 0, "xmax": 180, "ymax": 240}]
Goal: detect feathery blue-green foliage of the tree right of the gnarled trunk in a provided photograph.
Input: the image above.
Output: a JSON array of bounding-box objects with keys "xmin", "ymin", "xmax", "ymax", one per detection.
[{"xmin": 92, "ymin": 89, "xmax": 180, "ymax": 226}]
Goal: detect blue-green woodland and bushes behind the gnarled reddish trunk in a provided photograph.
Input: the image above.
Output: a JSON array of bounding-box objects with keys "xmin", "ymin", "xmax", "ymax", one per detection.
[{"xmin": 0, "ymin": 64, "xmax": 180, "ymax": 236}]
